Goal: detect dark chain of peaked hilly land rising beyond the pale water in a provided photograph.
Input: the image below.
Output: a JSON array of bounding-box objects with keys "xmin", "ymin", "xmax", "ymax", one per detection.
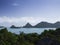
[{"xmin": 10, "ymin": 21, "xmax": 60, "ymax": 28}]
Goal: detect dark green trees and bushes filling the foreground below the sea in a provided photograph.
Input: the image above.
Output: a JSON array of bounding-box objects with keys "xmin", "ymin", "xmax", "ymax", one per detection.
[{"xmin": 0, "ymin": 28, "xmax": 60, "ymax": 45}]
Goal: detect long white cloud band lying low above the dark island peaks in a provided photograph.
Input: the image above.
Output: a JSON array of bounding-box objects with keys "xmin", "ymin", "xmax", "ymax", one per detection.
[{"xmin": 0, "ymin": 16, "xmax": 58, "ymax": 26}]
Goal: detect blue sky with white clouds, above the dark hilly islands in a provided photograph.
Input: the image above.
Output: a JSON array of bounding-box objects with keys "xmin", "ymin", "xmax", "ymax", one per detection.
[{"xmin": 0, "ymin": 0, "xmax": 60, "ymax": 26}]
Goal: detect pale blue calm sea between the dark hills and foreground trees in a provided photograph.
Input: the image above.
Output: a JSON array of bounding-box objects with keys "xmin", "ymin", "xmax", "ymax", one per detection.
[{"xmin": 4, "ymin": 28, "xmax": 56, "ymax": 34}]
